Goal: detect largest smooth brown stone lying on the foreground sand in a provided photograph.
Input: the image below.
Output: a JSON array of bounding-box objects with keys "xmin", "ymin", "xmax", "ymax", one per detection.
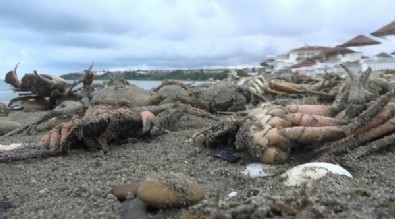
[{"xmin": 137, "ymin": 173, "xmax": 204, "ymax": 208}]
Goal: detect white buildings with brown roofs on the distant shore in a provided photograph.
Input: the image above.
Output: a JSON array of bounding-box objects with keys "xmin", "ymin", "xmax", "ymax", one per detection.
[{"xmin": 261, "ymin": 46, "xmax": 395, "ymax": 75}]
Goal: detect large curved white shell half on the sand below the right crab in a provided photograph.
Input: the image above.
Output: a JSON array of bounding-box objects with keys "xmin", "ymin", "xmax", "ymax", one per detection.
[{"xmin": 282, "ymin": 162, "xmax": 352, "ymax": 186}]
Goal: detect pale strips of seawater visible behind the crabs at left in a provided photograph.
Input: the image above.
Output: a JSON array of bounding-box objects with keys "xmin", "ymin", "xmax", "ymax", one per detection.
[{"xmin": 0, "ymin": 80, "xmax": 161, "ymax": 104}]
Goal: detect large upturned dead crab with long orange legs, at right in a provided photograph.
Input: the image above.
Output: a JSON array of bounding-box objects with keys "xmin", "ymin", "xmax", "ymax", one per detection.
[{"xmin": 192, "ymin": 66, "xmax": 395, "ymax": 164}]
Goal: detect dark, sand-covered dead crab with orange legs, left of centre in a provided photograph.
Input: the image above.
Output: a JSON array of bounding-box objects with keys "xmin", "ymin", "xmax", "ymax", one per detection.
[{"xmin": 40, "ymin": 105, "xmax": 161, "ymax": 153}]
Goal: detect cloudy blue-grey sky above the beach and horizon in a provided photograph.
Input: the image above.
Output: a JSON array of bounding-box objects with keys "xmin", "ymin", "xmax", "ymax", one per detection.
[{"xmin": 0, "ymin": 0, "xmax": 395, "ymax": 79}]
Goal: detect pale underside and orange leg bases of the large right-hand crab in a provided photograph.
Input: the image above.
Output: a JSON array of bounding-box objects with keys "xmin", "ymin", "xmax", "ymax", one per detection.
[{"xmin": 236, "ymin": 104, "xmax": 344, "ymax": 164}]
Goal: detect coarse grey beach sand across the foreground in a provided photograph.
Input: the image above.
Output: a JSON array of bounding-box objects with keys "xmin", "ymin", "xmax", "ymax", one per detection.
[{"xmin": 0, "ymin": 112, "xmax": 395, "ymax": 218}]
